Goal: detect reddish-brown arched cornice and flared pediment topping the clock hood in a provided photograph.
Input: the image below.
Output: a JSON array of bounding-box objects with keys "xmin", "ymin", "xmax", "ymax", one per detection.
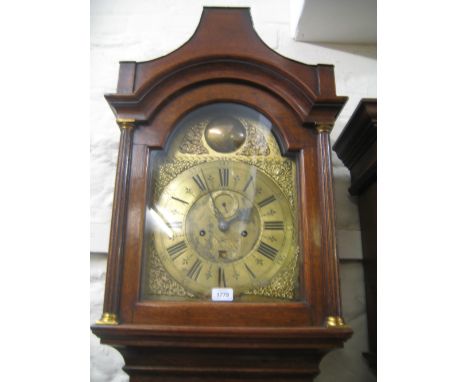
[{"xmin": 105, "ymin": 7, "xmax": 347, "ymax": 124}]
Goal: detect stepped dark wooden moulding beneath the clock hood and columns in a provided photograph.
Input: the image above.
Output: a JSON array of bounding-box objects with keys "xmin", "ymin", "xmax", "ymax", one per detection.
[{"xmin": 95, "ymin": 324, "xmax": 351, "ymax": 382}]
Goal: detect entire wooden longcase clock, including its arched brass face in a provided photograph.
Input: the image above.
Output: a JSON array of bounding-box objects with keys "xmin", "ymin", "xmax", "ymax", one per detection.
[{"xmin": 92, "ymin": 8, "xmax": 352, "ymax": 382}]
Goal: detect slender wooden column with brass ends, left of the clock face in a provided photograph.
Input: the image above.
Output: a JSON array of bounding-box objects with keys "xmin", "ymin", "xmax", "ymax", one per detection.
[{"xmin": 96, "ymin": 119, "xmax": 135, "ymax": 325}]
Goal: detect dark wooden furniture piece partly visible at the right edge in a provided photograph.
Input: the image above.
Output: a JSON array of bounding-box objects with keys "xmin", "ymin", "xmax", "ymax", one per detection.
[{"xmin": 333, "ymin": 99, "xmax": 377, "ymax": 369}]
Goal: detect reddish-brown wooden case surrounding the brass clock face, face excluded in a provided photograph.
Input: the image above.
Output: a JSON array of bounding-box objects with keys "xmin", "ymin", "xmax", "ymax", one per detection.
[{"xmin": 92, "ymin": 8, "xmax": 352, "ymax": 382}]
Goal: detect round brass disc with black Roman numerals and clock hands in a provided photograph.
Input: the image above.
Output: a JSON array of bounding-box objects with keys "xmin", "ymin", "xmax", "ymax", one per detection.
[{"xmin": 153, "ymin": 160, "xmax": 295, "ymax": 295}]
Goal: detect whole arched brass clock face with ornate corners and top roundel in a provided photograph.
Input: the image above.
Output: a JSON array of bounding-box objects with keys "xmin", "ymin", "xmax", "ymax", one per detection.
[{"xmin": 142, "ymin": 104, "xmax": 299, "ymax": 301}]
